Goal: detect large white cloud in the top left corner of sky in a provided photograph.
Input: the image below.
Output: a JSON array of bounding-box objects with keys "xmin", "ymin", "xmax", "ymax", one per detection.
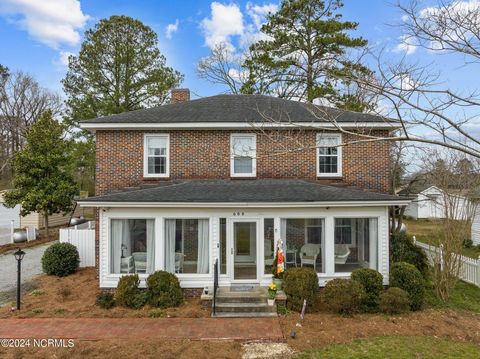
[{"xmin": 0, "ymin": 0, "xmax": 89, "ymax": 48}]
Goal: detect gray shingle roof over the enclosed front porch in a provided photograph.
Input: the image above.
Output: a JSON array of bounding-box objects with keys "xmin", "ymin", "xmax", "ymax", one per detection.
[{"xmin": 79, "ymin": 179, "xmax": 405, "ymax": 203}]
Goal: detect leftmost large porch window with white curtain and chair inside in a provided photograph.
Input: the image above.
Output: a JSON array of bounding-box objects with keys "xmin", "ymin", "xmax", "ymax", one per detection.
[{"xmin": 110, "ymin": 219, "xmax": 155, "ymax": 274}]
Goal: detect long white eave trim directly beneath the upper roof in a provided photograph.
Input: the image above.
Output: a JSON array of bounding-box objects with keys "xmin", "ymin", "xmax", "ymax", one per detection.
[{"xmin": 80, "ymin": 121, "xmax": 400, "ymax": 132}]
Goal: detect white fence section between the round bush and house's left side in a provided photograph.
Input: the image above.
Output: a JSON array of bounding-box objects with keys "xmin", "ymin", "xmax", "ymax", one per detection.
[{"xmin": 60, "ymin": 222, "xmax": 95, "ymax": 267}]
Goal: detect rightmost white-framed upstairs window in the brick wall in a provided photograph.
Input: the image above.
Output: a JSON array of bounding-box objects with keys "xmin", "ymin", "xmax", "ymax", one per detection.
[{"xmin": 317, "ymin": 133, "xmax": 342, "ymax": 177}]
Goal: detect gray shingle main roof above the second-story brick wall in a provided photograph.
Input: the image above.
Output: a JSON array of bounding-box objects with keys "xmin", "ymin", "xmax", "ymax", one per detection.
[{"xmin": 79, "ymin": 95, "xmax": 395, "ymax": 124}]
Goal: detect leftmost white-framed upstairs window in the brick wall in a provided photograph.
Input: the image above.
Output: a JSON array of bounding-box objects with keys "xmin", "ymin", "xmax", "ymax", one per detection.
[{"xmin": 143, "ymin": 134, "xmax": 170, "ymax": 177}]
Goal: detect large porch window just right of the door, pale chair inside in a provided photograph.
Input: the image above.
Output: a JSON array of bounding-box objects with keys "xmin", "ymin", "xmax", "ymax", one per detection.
[{"xmin": 280, "ymin": 218, "xmax": 325, "ymax": 273}]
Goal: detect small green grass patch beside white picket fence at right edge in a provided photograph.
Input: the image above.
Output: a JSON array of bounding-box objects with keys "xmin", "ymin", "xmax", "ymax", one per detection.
[{"xmin": 426, "ymin": 281, "xmax": 480, "ymax": 313}]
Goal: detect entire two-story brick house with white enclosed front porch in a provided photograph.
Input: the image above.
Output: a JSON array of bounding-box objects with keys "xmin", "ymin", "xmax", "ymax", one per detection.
[{"xmin": 79, "ymin": 89, "xmax": 409, "ymax": 294}]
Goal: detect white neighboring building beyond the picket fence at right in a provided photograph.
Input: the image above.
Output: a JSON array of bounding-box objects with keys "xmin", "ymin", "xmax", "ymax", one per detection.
[{"xmin": 398, "ymin": 183, "xmax": 469, "ymax": 219}]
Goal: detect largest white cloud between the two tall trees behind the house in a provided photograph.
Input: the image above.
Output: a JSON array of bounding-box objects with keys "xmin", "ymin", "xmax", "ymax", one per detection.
[{"xmin": 201, "ymin": 2, "xmax": 244, "ymax": 49}]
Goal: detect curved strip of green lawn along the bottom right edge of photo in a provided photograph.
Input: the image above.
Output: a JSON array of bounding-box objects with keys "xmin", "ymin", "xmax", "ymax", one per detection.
[{"xmin": 299, "ymin": 336, "xmax": 480, "ymax": 359}]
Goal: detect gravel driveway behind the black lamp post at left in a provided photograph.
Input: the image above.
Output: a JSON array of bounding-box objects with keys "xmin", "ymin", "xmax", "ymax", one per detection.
[{"xmin": 0, "ymin": 242, "xmax": 55, "ymax": 293}]
